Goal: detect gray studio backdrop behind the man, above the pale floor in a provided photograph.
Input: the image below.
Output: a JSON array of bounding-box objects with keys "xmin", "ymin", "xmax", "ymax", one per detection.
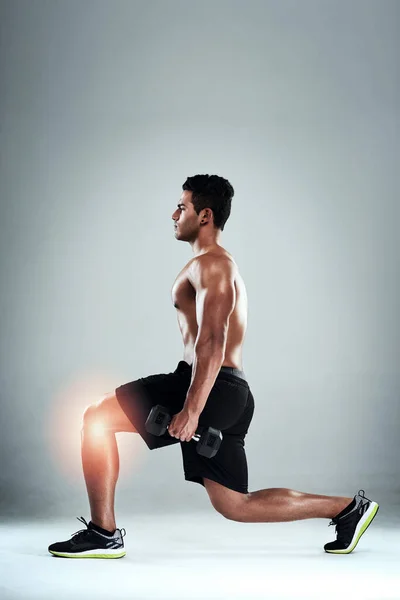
[{"xmin": 0, "ymin": 0, "xmax": 400, "ymax": 517}]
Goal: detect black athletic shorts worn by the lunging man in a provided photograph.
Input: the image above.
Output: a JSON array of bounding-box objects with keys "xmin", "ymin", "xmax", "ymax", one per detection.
[{"xmin": 115, "ymin": 361, "xmax": 254, "ymax": 494}]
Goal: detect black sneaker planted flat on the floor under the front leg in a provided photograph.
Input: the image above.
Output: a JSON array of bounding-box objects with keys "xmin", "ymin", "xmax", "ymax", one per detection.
[{"xmin": 49, "ymin": 517, "xmax": 126, "ymax": 558}]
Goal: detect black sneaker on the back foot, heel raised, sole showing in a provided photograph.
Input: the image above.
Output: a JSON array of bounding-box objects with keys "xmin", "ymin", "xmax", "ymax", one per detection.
[{"xmin": 324, "ymin": 490, "xmax": 379, "ymax": 554}]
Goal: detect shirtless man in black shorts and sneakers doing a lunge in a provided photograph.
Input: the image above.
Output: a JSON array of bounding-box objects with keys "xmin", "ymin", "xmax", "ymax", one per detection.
[{"xmin": 49, "ymin": 175, "xmax": 379, "ymax": 558}]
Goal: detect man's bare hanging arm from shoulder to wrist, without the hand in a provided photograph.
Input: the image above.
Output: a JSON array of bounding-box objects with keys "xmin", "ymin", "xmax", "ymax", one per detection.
[{"xmin": 184, "ymin": 256, "xmax": 236, "ymax": 416}]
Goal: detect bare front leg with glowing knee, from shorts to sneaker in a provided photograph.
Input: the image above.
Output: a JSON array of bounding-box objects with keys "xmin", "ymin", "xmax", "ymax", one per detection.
[{"xmin": 81, "ymin": 393, "xmax": 137, "ymax": 531}]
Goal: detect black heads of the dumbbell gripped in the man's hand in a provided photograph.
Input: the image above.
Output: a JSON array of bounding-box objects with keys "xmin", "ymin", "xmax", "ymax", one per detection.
[{"xmin": 145, "ymin": 404, "xmax": 222, "ymax": 458}]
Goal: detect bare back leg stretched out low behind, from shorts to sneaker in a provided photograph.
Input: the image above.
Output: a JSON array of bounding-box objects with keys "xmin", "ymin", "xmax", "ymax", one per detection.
[{"xmin": 204, "ymin": 478, "xmax": 353, "ymax": 523}]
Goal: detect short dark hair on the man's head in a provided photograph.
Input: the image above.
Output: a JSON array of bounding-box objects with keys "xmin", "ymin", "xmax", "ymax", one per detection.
[{"xmin": 182, "ymin": 175, "xmax": 235, "ymax": 231}]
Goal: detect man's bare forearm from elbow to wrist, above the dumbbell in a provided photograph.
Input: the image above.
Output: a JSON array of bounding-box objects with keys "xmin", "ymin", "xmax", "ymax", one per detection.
[{"xmin": 184, "ymin": 340, "xmax": 225, "ymax": 416}]
